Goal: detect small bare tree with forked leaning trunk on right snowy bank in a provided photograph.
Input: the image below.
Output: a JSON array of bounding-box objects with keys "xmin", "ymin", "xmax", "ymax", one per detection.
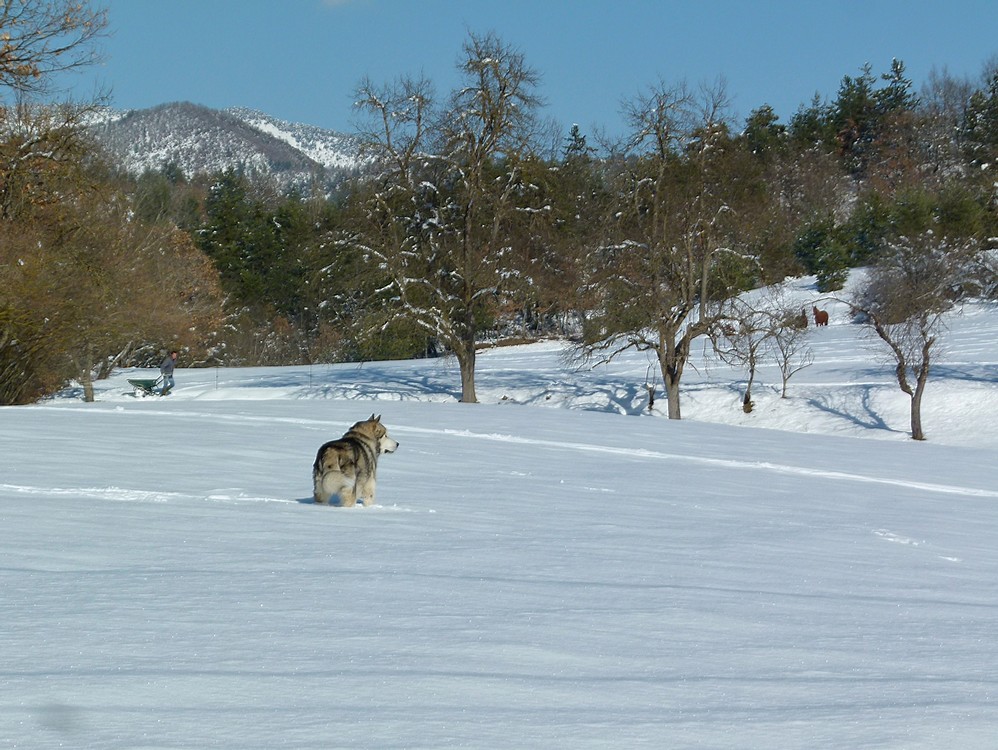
[{"xmin": 851, "ymin": 231, "xmax": 981, "ymax": 440}]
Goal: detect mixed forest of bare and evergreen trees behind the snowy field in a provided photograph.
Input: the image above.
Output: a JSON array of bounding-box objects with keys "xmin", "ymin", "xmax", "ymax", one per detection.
[{"xmin": 0, "ymin": 0, "xmax": 998, "ymax": 417}]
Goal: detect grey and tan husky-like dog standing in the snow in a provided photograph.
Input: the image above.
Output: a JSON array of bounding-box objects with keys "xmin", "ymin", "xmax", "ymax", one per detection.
[{"xmin": 312, "ymin": 414, "xmax": 399, "ymax": 507}]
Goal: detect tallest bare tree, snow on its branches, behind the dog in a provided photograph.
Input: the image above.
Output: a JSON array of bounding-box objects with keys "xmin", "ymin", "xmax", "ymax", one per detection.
[{"xmin": 358, "ymin": 34, "xmax": 540, "ymax": 402}]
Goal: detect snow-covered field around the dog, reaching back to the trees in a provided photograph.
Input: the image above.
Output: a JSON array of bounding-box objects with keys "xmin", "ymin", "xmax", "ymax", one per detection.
[{"xmin": 0, "ymin": 283, "xmax": 998, "ymax": 750}]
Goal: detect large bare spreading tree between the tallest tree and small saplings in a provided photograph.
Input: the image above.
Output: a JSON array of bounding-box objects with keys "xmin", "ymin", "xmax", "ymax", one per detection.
[{"xmin": 579, "ymin": 85, "xmax": 755, "ymax": 419}]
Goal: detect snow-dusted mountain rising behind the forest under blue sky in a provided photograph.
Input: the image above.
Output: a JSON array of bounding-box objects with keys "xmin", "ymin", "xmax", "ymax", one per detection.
[{"xmin": 91, "ymin": 102, "xmax": 362, "ymax": 189}]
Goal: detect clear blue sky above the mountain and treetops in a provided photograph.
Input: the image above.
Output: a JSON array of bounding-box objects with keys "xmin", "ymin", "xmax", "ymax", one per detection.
[{"xmin": 68, "ymin": 0, "xmax": 998, "ymax": 140}]
